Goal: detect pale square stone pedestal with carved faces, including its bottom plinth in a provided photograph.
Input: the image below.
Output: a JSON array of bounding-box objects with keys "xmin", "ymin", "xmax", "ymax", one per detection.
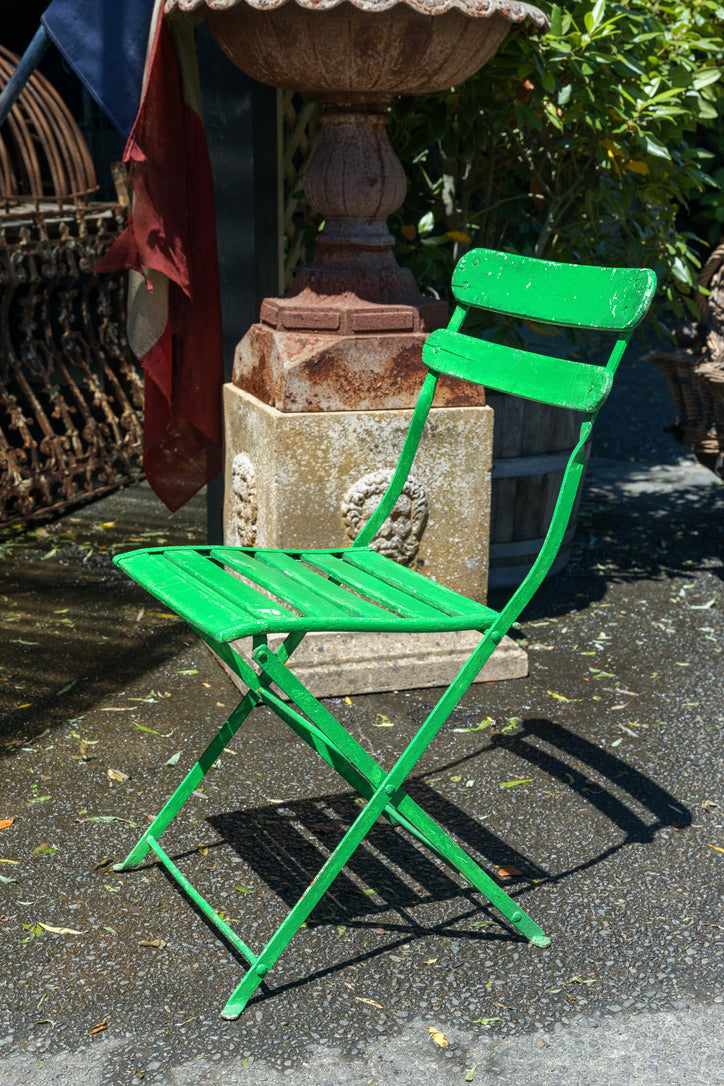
[{"xmin": 224, "ymin": 384, "xmax": 528, "ymax": 697}]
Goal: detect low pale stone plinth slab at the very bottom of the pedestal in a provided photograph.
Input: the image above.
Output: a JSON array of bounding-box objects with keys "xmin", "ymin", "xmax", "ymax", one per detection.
[{"xmin": 218, "ymin": 631, "xmax": 528, "ymax": 697}]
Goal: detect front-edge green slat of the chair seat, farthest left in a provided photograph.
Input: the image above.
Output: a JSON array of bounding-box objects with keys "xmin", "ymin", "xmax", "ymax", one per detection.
[{"xmin": 114, "ymin": 551, "xmax": 257, "ymax": 637}]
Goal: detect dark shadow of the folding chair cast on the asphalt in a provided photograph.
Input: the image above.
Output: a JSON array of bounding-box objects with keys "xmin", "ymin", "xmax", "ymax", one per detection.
[{"xmin": 171, "ymin": 719, "xmax": 691, "ymax": 1001}]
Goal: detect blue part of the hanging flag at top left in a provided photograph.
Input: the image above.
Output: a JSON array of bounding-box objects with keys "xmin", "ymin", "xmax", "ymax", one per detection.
[{"xmin": 42, "ymin": 0, "xmax": 154, "ymax": 139}]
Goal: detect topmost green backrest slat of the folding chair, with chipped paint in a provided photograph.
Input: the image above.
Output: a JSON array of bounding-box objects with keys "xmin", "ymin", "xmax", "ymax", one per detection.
[{"xmin": 453, "ymin": 249, "xmax": 657, "ymax": 332}]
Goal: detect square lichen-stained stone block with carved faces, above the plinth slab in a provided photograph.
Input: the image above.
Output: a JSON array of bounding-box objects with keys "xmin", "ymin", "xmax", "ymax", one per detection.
[{"xmin": 224, "ymin": 384, "xmax": 493, "ymax": 602}]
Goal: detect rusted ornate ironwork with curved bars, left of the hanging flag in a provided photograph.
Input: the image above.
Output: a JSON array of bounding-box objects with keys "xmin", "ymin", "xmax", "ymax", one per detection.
[{"xmin": 0, "ymin": 47, "xmax": 143, "ymax": 525}]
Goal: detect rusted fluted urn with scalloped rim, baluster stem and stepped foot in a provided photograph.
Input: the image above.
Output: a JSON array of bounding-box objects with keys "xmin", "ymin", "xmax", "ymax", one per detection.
[{"xmin": 166, "ymin": 0, "xmax": 548, "ymax": 331}]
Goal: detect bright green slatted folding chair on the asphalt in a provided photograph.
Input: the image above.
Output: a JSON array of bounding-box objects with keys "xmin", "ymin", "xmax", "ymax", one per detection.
[{"xmin": 115, "ymin": 250, "xmax": 656, "ymax": 1019}]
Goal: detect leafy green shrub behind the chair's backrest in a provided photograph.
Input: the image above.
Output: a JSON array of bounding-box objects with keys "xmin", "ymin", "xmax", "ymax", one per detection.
[{"xmin": 390, "ymin": 0, "xmax": 724, "ymax": 316}]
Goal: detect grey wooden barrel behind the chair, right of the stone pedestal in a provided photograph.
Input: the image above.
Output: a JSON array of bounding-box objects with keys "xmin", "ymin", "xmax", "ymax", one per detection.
[{"xmin": 486, "ymin": 392, "xmax": 581, "ymax": 589}]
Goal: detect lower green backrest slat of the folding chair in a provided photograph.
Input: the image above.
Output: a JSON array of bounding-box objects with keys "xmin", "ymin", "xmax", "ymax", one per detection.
[{"xmin": 422, "ymin": 328, "xmax": 613, "ymax": 411}]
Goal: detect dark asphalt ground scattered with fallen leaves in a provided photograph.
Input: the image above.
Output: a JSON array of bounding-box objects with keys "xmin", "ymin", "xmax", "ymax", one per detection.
[{"xmin": 0, "ymin": 349, "xmax": 724, "ymax": 1086}]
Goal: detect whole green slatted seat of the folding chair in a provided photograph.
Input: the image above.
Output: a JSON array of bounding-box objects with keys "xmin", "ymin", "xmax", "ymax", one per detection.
[{"xmin": 117, "ymin": 546, "xmax": 497, "ymax": 642}]
